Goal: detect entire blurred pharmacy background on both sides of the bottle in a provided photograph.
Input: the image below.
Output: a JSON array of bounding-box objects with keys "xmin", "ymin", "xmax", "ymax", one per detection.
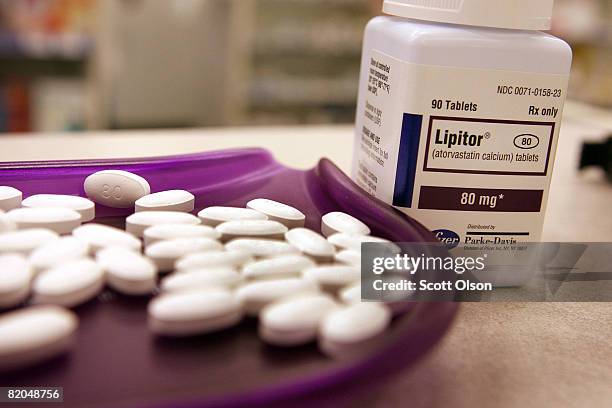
[{"xmin": 0, "ymin": 0, "xmax": 612, "ymax": 132}]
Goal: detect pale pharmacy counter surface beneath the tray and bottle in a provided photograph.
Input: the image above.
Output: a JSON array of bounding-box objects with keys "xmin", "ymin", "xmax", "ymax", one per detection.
[{"xmin": 0, "ymin": 106, "xmax": 612, "ymax": 408}]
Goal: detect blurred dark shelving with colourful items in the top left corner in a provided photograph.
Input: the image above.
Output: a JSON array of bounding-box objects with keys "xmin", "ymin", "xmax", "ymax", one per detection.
[{"xmin": 0, "ymin": 0, "xmax": 96, "ymax": 132}]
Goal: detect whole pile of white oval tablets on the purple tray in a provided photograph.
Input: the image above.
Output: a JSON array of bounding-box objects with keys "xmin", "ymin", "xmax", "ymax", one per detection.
[{"xmin": 0, "ymin": 170, "xmax": 391, "ymax": 370}]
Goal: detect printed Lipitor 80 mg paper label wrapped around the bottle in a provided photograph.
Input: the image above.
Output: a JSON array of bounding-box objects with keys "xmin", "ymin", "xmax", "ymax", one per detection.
[{"xmin": 353, "ymin": 50, "xmax": 568, "ymax": 243}]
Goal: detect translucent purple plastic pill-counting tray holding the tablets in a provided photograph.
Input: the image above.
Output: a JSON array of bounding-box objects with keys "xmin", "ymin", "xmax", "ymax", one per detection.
[{"xmin": 0, "ymin": 149, "xmax": 457, "ymax": 408}]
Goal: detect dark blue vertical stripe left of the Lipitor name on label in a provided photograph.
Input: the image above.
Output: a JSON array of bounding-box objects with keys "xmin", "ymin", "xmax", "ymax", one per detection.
[{"xmin": 393, "ymin": 113, "xmax": 423, "ymax": 208}]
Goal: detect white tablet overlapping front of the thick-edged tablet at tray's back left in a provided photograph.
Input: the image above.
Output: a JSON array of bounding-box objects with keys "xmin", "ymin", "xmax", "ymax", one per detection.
[{"xmin": 6, "ymin": 208, "xmax": 81, "ymax": 234}]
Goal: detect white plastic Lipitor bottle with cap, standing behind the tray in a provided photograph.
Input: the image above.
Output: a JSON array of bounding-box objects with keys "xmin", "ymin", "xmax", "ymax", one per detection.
[{"xmin": 352, "ymin": 0, "xmax": 572, "ymax": 247}]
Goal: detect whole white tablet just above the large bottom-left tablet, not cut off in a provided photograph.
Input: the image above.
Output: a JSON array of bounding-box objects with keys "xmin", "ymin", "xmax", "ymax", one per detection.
[{"xmin": 32, "ymin": 259, "xmax": 104, "ymax": 307}]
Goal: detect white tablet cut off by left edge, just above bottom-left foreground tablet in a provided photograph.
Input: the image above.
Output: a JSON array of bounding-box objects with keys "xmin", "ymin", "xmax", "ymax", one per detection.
[{"xmin": 0, "ymin": 254, "xmax": 32, "ymax": 309}]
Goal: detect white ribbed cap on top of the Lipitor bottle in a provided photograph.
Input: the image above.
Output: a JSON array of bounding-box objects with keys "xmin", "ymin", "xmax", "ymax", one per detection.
[{"xmin": 383, "ymin": 0, "xmax": 554, "ymax": 30}]
